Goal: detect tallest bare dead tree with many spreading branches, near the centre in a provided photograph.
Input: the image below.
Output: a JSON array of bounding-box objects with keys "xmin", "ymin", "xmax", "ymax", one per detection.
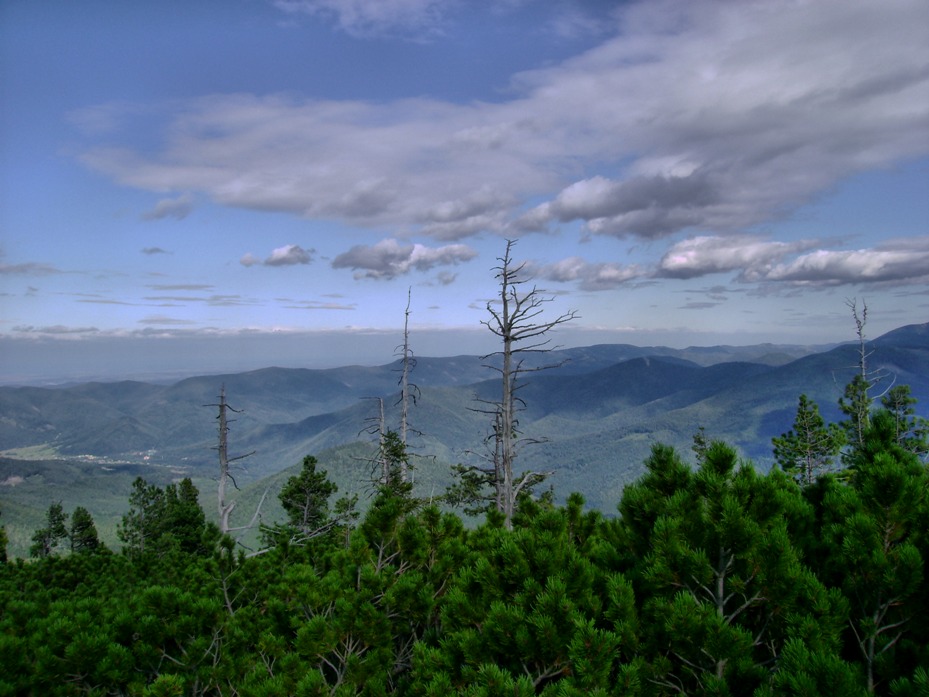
[{"xmin": 481, "ymin": 240, "xmax": 577, "ymax": 527}]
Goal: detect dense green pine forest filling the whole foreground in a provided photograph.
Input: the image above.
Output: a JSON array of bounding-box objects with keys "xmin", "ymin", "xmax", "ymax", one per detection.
[{"xmin": 0, "ymin": 377, "xmax": 929, "ymax": 697}]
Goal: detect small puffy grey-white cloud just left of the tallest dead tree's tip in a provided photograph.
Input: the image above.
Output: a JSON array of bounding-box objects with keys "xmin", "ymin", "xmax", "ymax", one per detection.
[{"xmin": 332, "ymin": 238, "xmax": 477, "ymax": 279}]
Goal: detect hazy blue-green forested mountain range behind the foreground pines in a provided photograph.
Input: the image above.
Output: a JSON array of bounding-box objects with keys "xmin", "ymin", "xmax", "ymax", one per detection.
[{"xmin": 0, "ymin": 323, "xmax": 929, "ymax": 544}]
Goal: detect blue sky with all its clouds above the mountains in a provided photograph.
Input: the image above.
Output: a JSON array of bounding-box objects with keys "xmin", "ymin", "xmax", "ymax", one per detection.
[{"xmin": 0, "ymin": 0, "xmax": 929, "ymax": 383}]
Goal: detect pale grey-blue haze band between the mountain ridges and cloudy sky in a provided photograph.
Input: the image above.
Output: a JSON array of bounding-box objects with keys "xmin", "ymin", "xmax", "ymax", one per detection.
[{"xmin": 0, "ymin": 323, "xmax": 872, "ymax": 386}]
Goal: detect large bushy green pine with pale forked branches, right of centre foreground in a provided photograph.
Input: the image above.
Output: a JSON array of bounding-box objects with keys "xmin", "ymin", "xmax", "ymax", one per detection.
[{"xmin": 617, "ymin": 442, "xmax": 835, "ymax": 694}]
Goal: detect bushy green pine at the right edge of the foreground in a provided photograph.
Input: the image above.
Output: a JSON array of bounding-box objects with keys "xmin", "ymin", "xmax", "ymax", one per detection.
[{"xmin": 823, "ymin": 410, "xmax": 929, "ymax": 693}]
